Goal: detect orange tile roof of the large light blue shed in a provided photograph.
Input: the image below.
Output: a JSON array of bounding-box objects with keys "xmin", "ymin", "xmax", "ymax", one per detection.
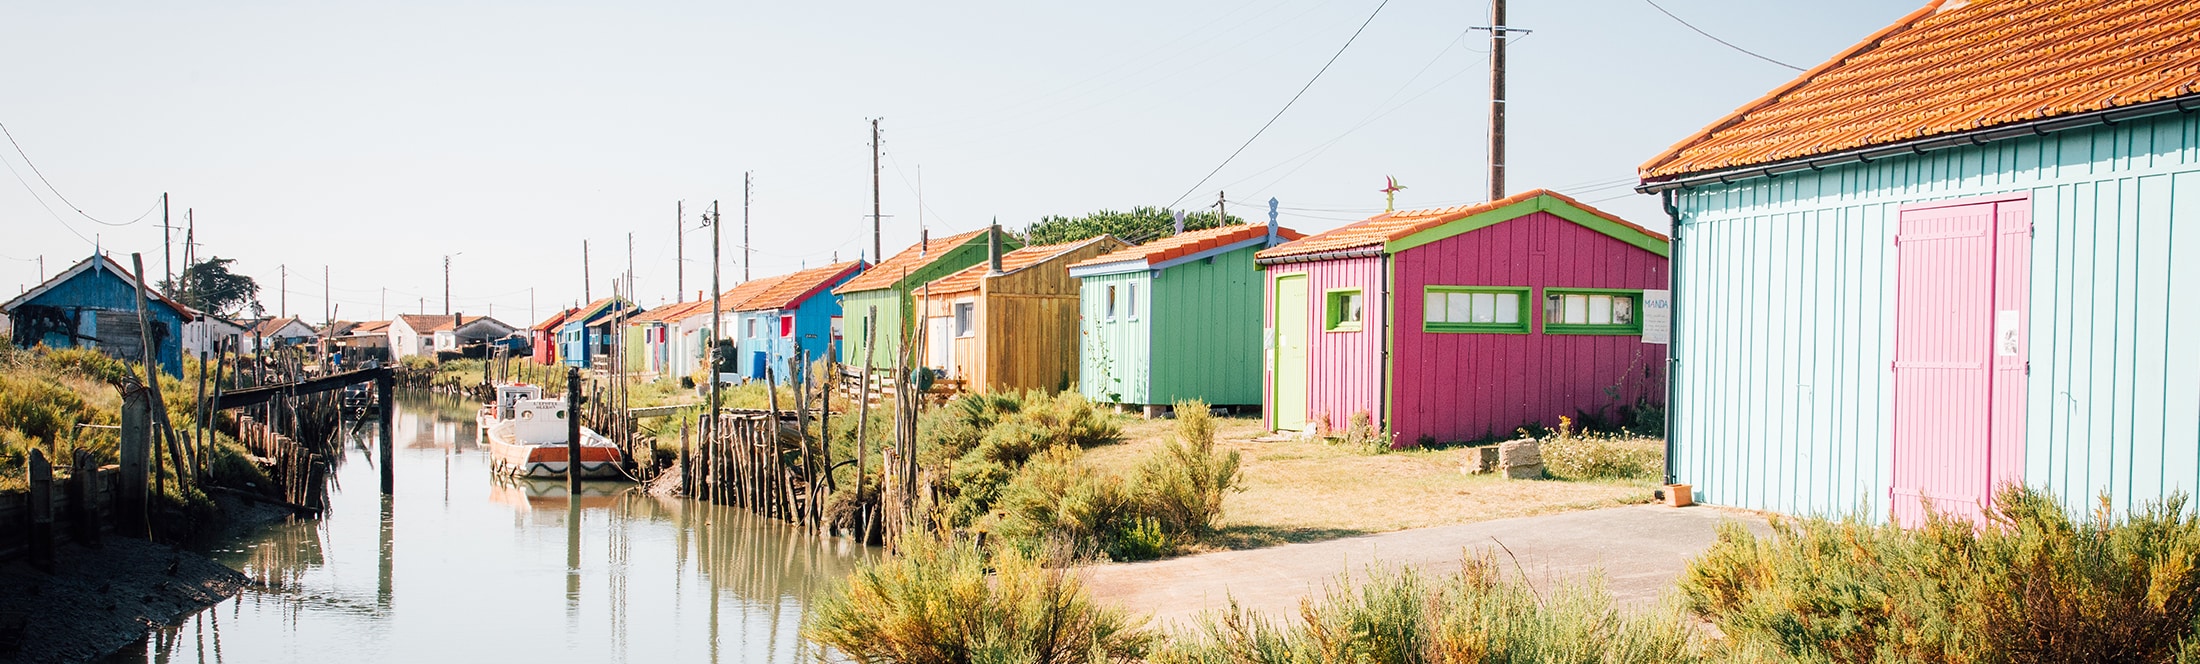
[{"xmin": 1639, "ymin": 0, "xmax": 2200, "ymax": 180}]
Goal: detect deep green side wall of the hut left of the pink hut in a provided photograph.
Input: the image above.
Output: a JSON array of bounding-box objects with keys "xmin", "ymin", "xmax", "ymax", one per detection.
[{"xmin": 1140, "ymin": 248, "xmax": 1263, "ymax": 405}]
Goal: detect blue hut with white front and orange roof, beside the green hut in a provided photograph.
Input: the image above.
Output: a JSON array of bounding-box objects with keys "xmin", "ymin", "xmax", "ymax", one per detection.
[{"xmin": 733, "ymin": 259, "xmax": 865, "ymax": 383}]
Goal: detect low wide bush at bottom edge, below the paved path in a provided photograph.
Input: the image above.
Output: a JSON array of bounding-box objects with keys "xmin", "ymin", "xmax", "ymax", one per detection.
[{"xmin": 1153, "ymin": 556, "xmax": 1709, "ymax": 664}]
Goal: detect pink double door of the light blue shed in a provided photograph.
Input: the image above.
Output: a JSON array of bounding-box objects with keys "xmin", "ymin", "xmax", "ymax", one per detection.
[{"xmin": 1888, "ymin": 200, "xmax": 2031, "ymax": 525}]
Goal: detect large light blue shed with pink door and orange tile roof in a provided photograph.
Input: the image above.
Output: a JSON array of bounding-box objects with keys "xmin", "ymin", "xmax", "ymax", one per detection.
[{"xmin": 1641, "ymin": 0, "xmax": 2200, "ymax": 523}]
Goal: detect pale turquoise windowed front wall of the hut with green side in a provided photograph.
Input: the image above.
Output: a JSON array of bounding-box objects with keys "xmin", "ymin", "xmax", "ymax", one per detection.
[{"xmin": 1078, "ymin": 270, "xmax": 1153, "ymax": 405}]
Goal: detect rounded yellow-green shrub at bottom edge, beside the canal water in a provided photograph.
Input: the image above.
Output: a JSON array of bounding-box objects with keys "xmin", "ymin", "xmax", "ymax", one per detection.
[{"xmin": 803, "ymin": 534, "xmax": 1151, "ymax": 664}]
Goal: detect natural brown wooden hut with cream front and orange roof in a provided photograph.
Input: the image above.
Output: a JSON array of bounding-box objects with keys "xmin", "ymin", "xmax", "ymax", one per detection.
[{"xmin": 915, "ymin": 231, "xmax": 1131, "ymax": 391}]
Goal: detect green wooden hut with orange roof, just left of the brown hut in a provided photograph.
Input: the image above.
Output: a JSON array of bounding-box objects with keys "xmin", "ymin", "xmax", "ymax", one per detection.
[{"xmin": 832, "ymin": 229, "xmax": 1021, "ymax": 369}]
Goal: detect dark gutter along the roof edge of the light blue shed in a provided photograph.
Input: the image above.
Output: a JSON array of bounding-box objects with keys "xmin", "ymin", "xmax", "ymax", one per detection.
[{"xmin": 1635, "ymin": 95, "xmax": 2200, "ymax": 194}]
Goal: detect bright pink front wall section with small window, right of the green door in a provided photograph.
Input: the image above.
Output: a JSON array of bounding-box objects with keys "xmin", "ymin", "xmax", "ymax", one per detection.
[{"xmin": 1263, "ymin": 257, "xmax": 1384, "ymax": 431}]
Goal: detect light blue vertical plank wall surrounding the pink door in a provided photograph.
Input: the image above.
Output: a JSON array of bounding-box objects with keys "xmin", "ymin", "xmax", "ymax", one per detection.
[{"xmin": 1672, "ymin": 112, "xmax": 2200, "ymax": 519}]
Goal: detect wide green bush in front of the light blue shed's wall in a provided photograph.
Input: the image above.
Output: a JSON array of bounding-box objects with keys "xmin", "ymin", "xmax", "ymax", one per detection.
[{"xmin": 1681, "ymin": 488, "xmax": 2200, "ymax": 662}]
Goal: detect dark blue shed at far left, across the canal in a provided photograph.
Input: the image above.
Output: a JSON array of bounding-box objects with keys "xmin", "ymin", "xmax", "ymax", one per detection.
[{"xmin": 0, "ymin": 255, "xmax": 196, "ymax": 378}]
